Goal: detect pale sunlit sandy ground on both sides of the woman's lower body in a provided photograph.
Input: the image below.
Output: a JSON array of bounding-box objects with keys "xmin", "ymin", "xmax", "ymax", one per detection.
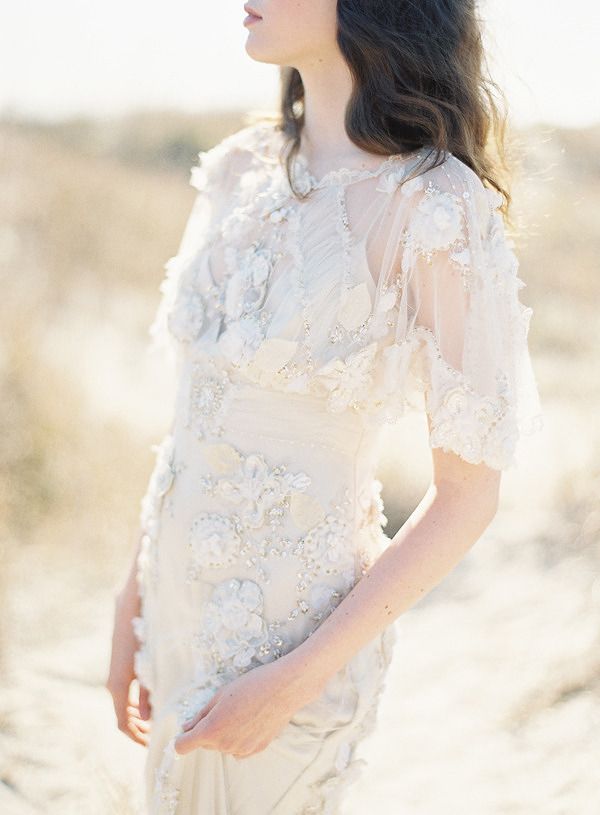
[{"xmin": 0, "ymin": 396, "xmax": 600, "ymax": 815}]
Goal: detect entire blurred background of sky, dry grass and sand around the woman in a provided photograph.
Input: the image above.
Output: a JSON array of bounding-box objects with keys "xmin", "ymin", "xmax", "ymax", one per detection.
[{"xmin": 0, "ymin": 0, "xmax": 600, "ymax": 815}]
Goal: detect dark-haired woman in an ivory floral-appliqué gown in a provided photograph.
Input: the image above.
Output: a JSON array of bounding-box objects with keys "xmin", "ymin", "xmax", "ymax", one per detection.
[{"xmin": 107, "ymin": 0, "xmax": 540, "ymax": 815}]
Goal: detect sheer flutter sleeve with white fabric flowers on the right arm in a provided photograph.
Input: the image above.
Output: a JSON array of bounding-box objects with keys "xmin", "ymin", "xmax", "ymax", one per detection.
[{"xmin": 382, "ymin": 155, "xmax": 542, "ymax": 469}]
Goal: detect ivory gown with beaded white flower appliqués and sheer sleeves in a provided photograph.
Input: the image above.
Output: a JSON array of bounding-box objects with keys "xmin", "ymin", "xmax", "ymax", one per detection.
[{"xmin": 134, "ymin": 122, "xmax": 540, "ymax": 815}]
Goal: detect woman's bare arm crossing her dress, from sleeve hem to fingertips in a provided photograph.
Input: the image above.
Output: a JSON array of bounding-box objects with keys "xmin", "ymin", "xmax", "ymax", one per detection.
[{"xmin": 175, "ymin": 449, "xmax": 500, "ymax": 757}]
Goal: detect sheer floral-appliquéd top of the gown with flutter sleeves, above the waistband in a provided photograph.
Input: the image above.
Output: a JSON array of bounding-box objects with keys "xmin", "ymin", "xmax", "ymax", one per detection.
[{"xmin": 151, "ymin": 117, "xmax": 540, "ymax": 468}]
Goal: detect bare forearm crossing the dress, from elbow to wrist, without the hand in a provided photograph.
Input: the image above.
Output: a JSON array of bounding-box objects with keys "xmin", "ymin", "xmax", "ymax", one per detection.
[{"xmin": 283, "ymin": 485, "xmax": 495, "ymax": 692}]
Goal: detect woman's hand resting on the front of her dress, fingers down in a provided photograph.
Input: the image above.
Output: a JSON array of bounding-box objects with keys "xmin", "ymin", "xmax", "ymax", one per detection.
[{"xmin": 175, "ymin": 657, "xmax": 321, "ymax": 758}]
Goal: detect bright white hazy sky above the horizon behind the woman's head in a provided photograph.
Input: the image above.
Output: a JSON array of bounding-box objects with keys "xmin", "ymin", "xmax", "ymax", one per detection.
[{"xmin": 0, "ymin": 0, "xmax": 600, "ymax": 126}]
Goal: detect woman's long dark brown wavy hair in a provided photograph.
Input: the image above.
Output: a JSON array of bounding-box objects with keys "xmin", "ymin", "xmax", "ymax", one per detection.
[{"xmin": 248, "ymin": 0, "xmax": 511, "ymax": 216}]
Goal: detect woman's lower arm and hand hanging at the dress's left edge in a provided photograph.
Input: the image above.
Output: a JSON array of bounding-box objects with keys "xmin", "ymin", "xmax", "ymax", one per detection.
[{"xmin": 104, "ymin": 586, "xmax": 152, "ymax": 747}]
